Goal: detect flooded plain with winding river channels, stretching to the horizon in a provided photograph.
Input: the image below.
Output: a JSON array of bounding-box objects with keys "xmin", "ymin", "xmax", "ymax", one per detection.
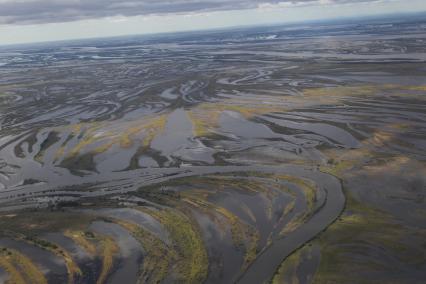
[{"xmin": 0, "ymin": 16, "xmax": 426, "ymax": 283}]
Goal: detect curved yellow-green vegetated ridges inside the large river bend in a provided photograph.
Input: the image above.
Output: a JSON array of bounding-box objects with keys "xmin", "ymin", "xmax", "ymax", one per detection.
[{"xmin": 148, "ymin": 173, "xmax": 317, "ymax": 270}]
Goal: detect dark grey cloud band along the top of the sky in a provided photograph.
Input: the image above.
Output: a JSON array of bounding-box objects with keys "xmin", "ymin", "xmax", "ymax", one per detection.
[{"xmin": 0, "ymin": 0, "xmax": 384, "ymax": 24}]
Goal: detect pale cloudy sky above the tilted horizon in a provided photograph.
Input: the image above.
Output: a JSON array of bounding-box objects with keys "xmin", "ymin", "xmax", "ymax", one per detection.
[{"xmin": 0, "ymin": 0, "xmax": 426, "ymax": 45}]
